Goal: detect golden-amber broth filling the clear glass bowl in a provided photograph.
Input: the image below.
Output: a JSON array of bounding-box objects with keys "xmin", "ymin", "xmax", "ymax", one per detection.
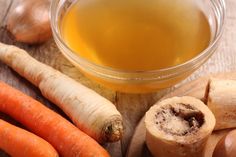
[{"xmin": 61, "ymin": 0, "xmax": 211, "ymax": 70}]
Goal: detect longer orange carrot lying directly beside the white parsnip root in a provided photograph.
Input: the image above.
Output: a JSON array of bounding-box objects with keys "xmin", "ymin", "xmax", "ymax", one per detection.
[{"xmin": 0, "ymin": 82, "xmax": 109, "ymax": 157}]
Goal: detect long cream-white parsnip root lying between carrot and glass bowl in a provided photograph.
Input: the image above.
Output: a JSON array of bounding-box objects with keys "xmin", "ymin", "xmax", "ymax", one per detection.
[{"xmin": 0, "ymin": 43, "xmax": 123, "ymax": 143}]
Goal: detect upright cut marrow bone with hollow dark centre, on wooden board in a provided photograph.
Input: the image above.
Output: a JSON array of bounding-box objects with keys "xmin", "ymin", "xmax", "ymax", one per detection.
[{"xmin": 145, "ymin": 96, "xmax": 215, "ymax": 157}]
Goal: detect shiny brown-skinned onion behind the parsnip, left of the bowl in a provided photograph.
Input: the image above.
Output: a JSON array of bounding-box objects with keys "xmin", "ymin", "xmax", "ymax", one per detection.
[{"xmin": 7, "ymin": 0, "xmax": 52, "ymax": 44}]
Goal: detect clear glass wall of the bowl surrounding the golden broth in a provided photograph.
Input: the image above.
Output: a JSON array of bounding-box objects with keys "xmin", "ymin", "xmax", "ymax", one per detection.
[{"xmin": 50, "ymin": 0, "xmax": 226, "ymax": 93}]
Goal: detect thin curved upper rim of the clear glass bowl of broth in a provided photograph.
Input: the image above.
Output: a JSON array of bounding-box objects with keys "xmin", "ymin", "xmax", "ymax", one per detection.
[{"xmin": 49, "ymin": 0, "xmax": 226, "ymax": 75}]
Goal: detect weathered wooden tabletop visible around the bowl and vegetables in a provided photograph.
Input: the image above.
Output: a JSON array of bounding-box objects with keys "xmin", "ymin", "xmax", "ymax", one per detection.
[{"xmin": 0, "ymin": 0, "xmax": 236, "ymax": 157}]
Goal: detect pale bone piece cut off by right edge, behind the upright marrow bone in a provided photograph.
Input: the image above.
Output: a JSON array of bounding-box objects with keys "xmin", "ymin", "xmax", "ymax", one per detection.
[{"xmin": 206, "ymin": 79, "xmax": 236, "ymax": 130}]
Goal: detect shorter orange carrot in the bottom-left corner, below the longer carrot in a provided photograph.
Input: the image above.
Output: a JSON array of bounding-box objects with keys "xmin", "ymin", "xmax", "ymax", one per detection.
[{"xmin": 0, "ymin": 119, "xmax": 58, "ymax": 157}]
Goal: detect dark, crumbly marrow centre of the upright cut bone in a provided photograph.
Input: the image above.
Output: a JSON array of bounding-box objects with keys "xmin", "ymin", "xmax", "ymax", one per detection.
[{"xmin": 155, "ymin": 103, "xmax": 204, "ymax": 136}]
